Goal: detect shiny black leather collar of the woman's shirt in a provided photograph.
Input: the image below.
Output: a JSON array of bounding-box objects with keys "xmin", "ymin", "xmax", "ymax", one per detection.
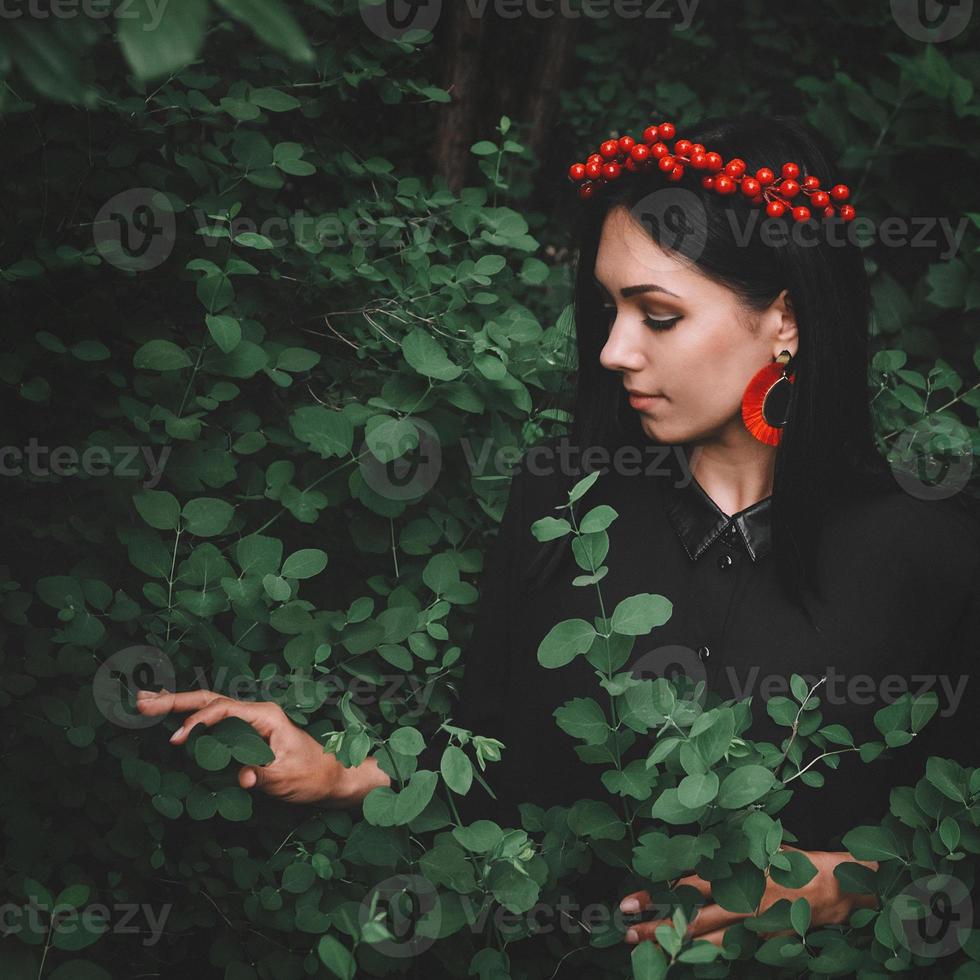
[{"xmin": 664, "ymin": 450, "xmax": 772, "ymax": 561}]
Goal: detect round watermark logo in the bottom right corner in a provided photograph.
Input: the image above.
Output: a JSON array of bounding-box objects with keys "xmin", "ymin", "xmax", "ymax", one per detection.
[{"xmin": 888, "ymin": 874, "xmax": 973, "ymax": 959}]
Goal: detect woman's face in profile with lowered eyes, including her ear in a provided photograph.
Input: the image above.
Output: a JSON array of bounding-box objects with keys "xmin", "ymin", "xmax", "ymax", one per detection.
[{"xmin": 594, "ymin": 207, "xmax": 797, "ymax": 444}]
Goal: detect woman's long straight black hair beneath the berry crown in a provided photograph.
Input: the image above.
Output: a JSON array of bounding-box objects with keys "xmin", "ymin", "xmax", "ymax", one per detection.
[{"xmin": 527, "ymin": 115, "xmax": 895, "ymax": 599}]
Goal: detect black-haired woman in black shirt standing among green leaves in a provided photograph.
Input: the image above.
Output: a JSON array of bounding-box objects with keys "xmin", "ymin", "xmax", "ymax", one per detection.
[{"xmin": 134, "ymin": 111, "xmax": 980, "ymax": 960}]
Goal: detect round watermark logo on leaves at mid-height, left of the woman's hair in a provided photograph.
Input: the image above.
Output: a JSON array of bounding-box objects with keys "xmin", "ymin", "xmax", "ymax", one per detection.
[{"xmin": 357, "ymin": 418, "xmax": 442, "ymax": 500}]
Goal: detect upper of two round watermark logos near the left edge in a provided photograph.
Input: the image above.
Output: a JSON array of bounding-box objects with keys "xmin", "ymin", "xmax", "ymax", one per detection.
[{"xmin": 92, "ymin": 187, "xmax": 177, "ymax": 272}]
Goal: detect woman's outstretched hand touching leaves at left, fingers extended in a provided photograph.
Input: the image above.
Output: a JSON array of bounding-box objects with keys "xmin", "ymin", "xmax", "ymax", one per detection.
[{"xmin": 136, "ymin": 690, "xmax": 390, "ymax": 807}]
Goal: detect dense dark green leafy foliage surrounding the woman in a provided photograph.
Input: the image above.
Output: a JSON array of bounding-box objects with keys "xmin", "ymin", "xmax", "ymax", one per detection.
[{"xmin": 0, "ymin": 0, "xmax": 980, "ymax": 980}]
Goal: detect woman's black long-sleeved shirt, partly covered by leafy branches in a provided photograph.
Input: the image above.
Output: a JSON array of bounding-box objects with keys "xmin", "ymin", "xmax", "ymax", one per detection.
[{"xmin": 419, "ymin": 437, "xmax": 980, "ymax": 904}]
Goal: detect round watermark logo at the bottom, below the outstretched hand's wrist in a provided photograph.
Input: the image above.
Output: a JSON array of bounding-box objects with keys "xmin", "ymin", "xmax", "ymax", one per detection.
[{"xmin": 358, "ymin": 874, "xmax": 442, "ymax": 959}]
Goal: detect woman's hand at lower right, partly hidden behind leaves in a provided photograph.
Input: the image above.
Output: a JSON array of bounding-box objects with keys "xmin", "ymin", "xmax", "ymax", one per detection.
[{"xmin": 619, "ymin": 844, "xmax": 878, "ymax": 946}]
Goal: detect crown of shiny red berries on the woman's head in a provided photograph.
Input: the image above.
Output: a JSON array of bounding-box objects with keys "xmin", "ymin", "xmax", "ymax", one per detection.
[{"xmin": 568, "ymin": 123, "xmax": 856, "ymax": 221}]
